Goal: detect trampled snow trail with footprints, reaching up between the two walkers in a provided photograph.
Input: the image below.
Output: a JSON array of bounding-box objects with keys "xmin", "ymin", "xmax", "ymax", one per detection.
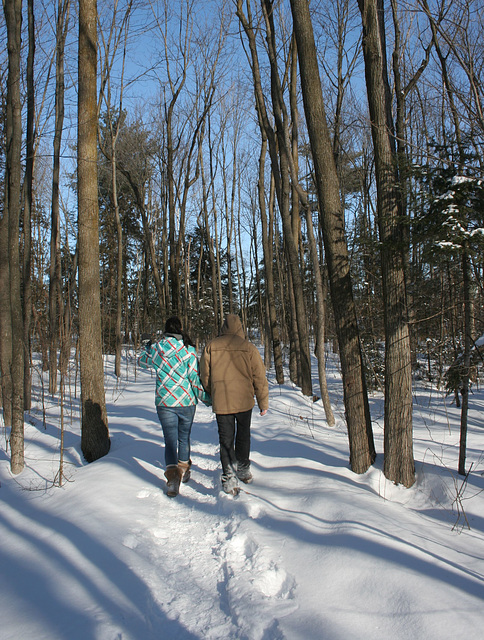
[{"xmin": 118, "ymin": 416, "xmax": 297, "ymax": 640}]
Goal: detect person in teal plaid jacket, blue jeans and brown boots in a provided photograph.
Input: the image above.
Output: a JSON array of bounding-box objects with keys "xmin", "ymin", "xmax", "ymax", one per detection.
[{"xmin": 138, "ymin": 316, "xmax": 210, "ymax": 497}]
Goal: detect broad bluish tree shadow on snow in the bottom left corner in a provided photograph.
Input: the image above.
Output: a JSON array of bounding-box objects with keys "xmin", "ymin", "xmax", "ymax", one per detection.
[{"xmin": 0, "ymin": 488, "xmax": 196, "ymax": 640}]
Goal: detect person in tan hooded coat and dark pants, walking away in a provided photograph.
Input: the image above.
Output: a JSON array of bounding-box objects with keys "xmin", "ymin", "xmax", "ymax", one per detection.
[{"xmin": 200, "ymin": 314, "xmax": 269, "ymax": 494}]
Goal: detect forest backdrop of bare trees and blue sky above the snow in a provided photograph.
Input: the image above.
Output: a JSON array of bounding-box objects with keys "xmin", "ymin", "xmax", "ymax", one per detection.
[{"xmin": 0, "ymin": 0, "xmax": 484, "ymax": 486}]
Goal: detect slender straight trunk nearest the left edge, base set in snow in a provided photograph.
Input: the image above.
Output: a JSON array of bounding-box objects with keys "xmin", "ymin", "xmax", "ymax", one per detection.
[{"xmin": 4, "ymin": 0, "xmax": 24, "ymax": 474}]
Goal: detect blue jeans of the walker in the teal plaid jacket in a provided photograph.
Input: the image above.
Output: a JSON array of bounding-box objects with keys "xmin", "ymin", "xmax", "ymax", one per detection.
[{"xmin": 156, "ymin": 404, "xmax": 196, "ymax": 466}]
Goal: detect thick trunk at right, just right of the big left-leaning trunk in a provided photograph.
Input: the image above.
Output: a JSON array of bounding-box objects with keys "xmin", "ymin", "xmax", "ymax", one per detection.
[{"xmin": 358, "ymin": 0, "xmax": 415, "ymax": 487}]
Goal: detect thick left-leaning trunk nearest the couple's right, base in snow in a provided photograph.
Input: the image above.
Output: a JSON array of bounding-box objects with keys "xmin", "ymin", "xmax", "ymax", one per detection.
[{"xmin": 291, "ymin": 0, "xmax": 375, "ymax": 473}]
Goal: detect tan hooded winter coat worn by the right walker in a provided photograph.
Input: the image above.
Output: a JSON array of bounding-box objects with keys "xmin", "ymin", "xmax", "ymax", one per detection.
[{"xmin": 200, "ymin": 314, "xmax": 269, "ymax": 414}]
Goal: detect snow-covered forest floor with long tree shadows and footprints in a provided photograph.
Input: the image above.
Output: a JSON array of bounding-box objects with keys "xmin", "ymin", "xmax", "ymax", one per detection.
[{"xmin": 0, "ymin": 352, "xmax": 484, "ymax": 640}]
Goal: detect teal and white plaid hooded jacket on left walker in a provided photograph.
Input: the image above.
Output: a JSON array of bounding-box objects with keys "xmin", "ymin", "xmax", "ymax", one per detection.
[{"xmin": 138, "ymin": 336, "xmax": 210, "ymax": 407}]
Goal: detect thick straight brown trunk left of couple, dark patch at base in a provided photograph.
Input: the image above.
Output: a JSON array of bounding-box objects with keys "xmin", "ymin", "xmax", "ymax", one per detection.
[{"xmin": 77, "ymin": 0, "xmax": 110, "ymax": 462}]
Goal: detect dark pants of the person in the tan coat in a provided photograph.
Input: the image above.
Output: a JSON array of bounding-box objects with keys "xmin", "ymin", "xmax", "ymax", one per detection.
[{"xmin": 217, "ymin": 409, "xmax": 252, "ymax": 476}]
